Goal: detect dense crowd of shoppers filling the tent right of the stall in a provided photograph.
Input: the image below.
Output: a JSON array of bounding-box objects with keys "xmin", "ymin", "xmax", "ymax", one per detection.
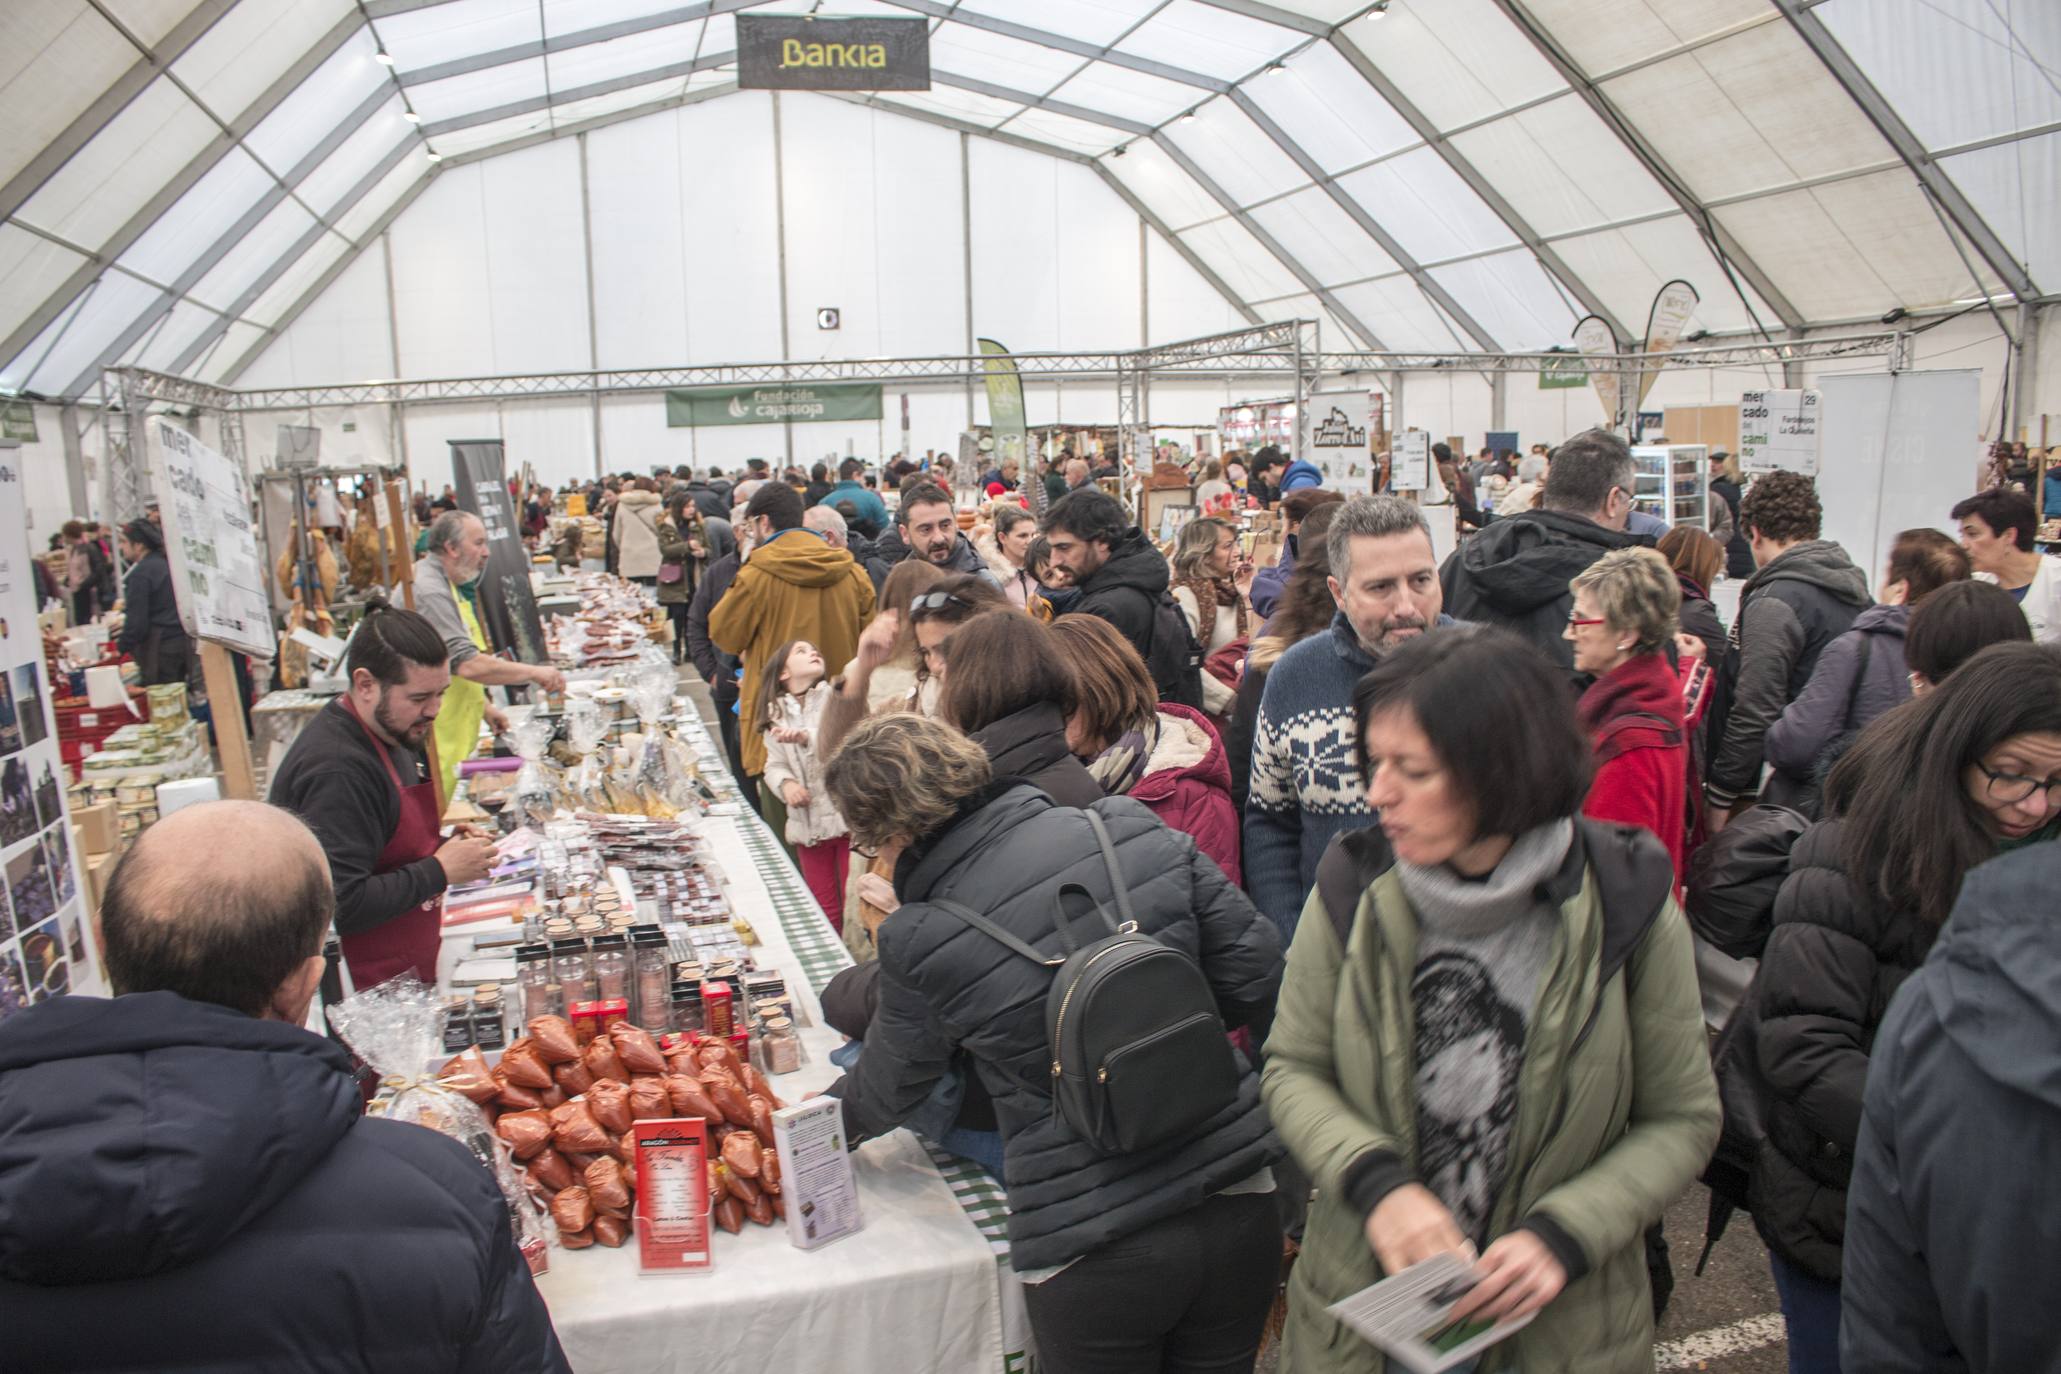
[{"xmin": 0, "ymin": 431, "xmax": 2061, "ymax": 1374}]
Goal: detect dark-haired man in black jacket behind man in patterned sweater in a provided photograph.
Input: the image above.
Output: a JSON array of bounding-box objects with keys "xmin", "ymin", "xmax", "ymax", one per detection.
[{"xmin": 1439, "ymin": 428, "xmax": 1653, "ymax": 674}]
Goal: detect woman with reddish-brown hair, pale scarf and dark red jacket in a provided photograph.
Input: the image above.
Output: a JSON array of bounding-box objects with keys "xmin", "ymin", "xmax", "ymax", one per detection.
[{"xmin": 1051, "ymin": 616, "xmax": 1243, "ymax": 886}]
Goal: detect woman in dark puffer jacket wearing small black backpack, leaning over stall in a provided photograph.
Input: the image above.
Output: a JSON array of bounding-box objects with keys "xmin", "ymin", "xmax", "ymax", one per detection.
[{"xmin": 824, "ymin": 713, "xmax": 1282, "ymax": 1374}]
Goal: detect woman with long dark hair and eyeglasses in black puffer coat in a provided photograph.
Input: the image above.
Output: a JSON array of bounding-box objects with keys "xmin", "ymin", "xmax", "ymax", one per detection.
[{"xmin": 1742, "ymin": 643, "xmax": 2061, "ymax": 1374}]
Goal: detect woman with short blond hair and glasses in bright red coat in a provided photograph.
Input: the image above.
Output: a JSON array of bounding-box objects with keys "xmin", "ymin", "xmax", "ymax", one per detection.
[{"xmin": 1566, "ymin": 548, "xmax": 1688, "ymax": 886}]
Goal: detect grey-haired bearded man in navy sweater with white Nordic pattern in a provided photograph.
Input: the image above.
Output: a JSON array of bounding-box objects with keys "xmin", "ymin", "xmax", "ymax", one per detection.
[{"xmin": 1245, "ymin": 496, "xmax": 1457, "ymax": 946}]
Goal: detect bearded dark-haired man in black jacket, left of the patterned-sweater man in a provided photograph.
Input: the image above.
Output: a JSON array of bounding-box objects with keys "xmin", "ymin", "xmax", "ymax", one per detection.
[{"xmin": 1043, "ymin": 486, "xmax": 1202, "ymax": 705}]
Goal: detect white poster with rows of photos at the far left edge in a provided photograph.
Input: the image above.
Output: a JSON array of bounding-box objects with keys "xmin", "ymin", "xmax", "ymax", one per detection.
[{"xmin": 0, "ymin": 453, "xmax": 107, "ymax": 1022}]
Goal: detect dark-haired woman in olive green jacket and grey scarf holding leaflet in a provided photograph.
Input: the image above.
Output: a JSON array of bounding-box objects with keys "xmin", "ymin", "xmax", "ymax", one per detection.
[{"xmin": 1265, "ymin": 628, "xmax": 1719, "ymax": 1374}]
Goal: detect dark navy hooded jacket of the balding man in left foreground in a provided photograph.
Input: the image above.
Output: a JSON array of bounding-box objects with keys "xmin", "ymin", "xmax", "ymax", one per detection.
[{"xmin": 0, "ymin": 993, "xmax": 567, "ymax": 1374}]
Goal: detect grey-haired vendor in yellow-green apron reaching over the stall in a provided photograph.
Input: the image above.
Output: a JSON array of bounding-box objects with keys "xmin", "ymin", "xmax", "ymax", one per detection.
[{"xmin": 414, "ymin": 511, "xmax": 565, "ymax": 797}]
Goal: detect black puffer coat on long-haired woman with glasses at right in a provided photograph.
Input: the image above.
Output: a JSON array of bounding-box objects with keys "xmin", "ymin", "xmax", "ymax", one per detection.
[{"xmin": 1752, "ymin": 820, "xmax": 1939, "ymax": 1281}]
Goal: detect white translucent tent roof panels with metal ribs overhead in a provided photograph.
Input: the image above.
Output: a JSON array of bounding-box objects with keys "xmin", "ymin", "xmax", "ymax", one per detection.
[{"xmin": 0, "ymin": 0, "xmax": 2061, "ymax": 396}]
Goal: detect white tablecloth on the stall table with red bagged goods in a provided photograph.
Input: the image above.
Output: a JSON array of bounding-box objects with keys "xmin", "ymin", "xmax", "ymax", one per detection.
[{"xmin": 515, "ymin": 818, "xmax": 1004, "ymax": 1374}]
